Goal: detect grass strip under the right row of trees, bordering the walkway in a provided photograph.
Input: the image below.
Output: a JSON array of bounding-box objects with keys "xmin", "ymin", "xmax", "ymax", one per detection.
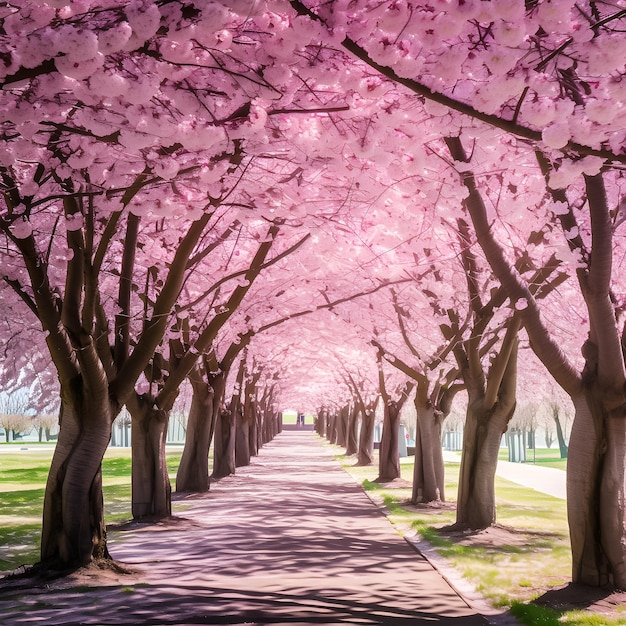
[{"xmin": 334, "ymin": 443, "xmax": 626, "ymax": 626}]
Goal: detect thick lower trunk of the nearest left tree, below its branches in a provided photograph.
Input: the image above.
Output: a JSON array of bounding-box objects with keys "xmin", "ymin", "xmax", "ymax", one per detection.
[{"xmin": 41, "ymin": 386, "xmax": 117, "ymax": 568}]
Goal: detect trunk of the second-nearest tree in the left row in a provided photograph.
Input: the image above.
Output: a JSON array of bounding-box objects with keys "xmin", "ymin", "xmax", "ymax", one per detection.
[{"xmin": 126, "ymin": 395, "xmax": 172, "ymax": 519}]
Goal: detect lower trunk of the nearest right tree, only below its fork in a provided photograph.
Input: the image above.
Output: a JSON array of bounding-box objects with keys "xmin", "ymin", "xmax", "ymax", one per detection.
[{"xmin": 567, "ymin": 388, "xmax": 626, "ymax": 589}]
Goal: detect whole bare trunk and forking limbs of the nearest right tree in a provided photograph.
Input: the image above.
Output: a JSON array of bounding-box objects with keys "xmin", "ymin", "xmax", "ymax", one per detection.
[{"xmin": 454, "ymin": 138, "xmax": 626, "ymax": 589}]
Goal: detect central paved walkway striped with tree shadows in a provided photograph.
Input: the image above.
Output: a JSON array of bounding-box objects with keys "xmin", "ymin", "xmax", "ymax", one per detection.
[{"xmin": 0, "ymin": 432, "xmax": 496, "ymax": 626}]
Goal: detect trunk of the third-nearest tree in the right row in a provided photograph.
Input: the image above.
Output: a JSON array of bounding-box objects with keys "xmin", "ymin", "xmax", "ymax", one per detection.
[{"xmin": 411, "ymin": 402, "xmax": 446, "ymax": 504}]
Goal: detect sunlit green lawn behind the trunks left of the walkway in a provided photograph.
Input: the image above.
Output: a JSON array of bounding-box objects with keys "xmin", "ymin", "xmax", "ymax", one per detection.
[{"xmin": 0, "ymin": 442, "xmax": 182, "ymax": 572}]
